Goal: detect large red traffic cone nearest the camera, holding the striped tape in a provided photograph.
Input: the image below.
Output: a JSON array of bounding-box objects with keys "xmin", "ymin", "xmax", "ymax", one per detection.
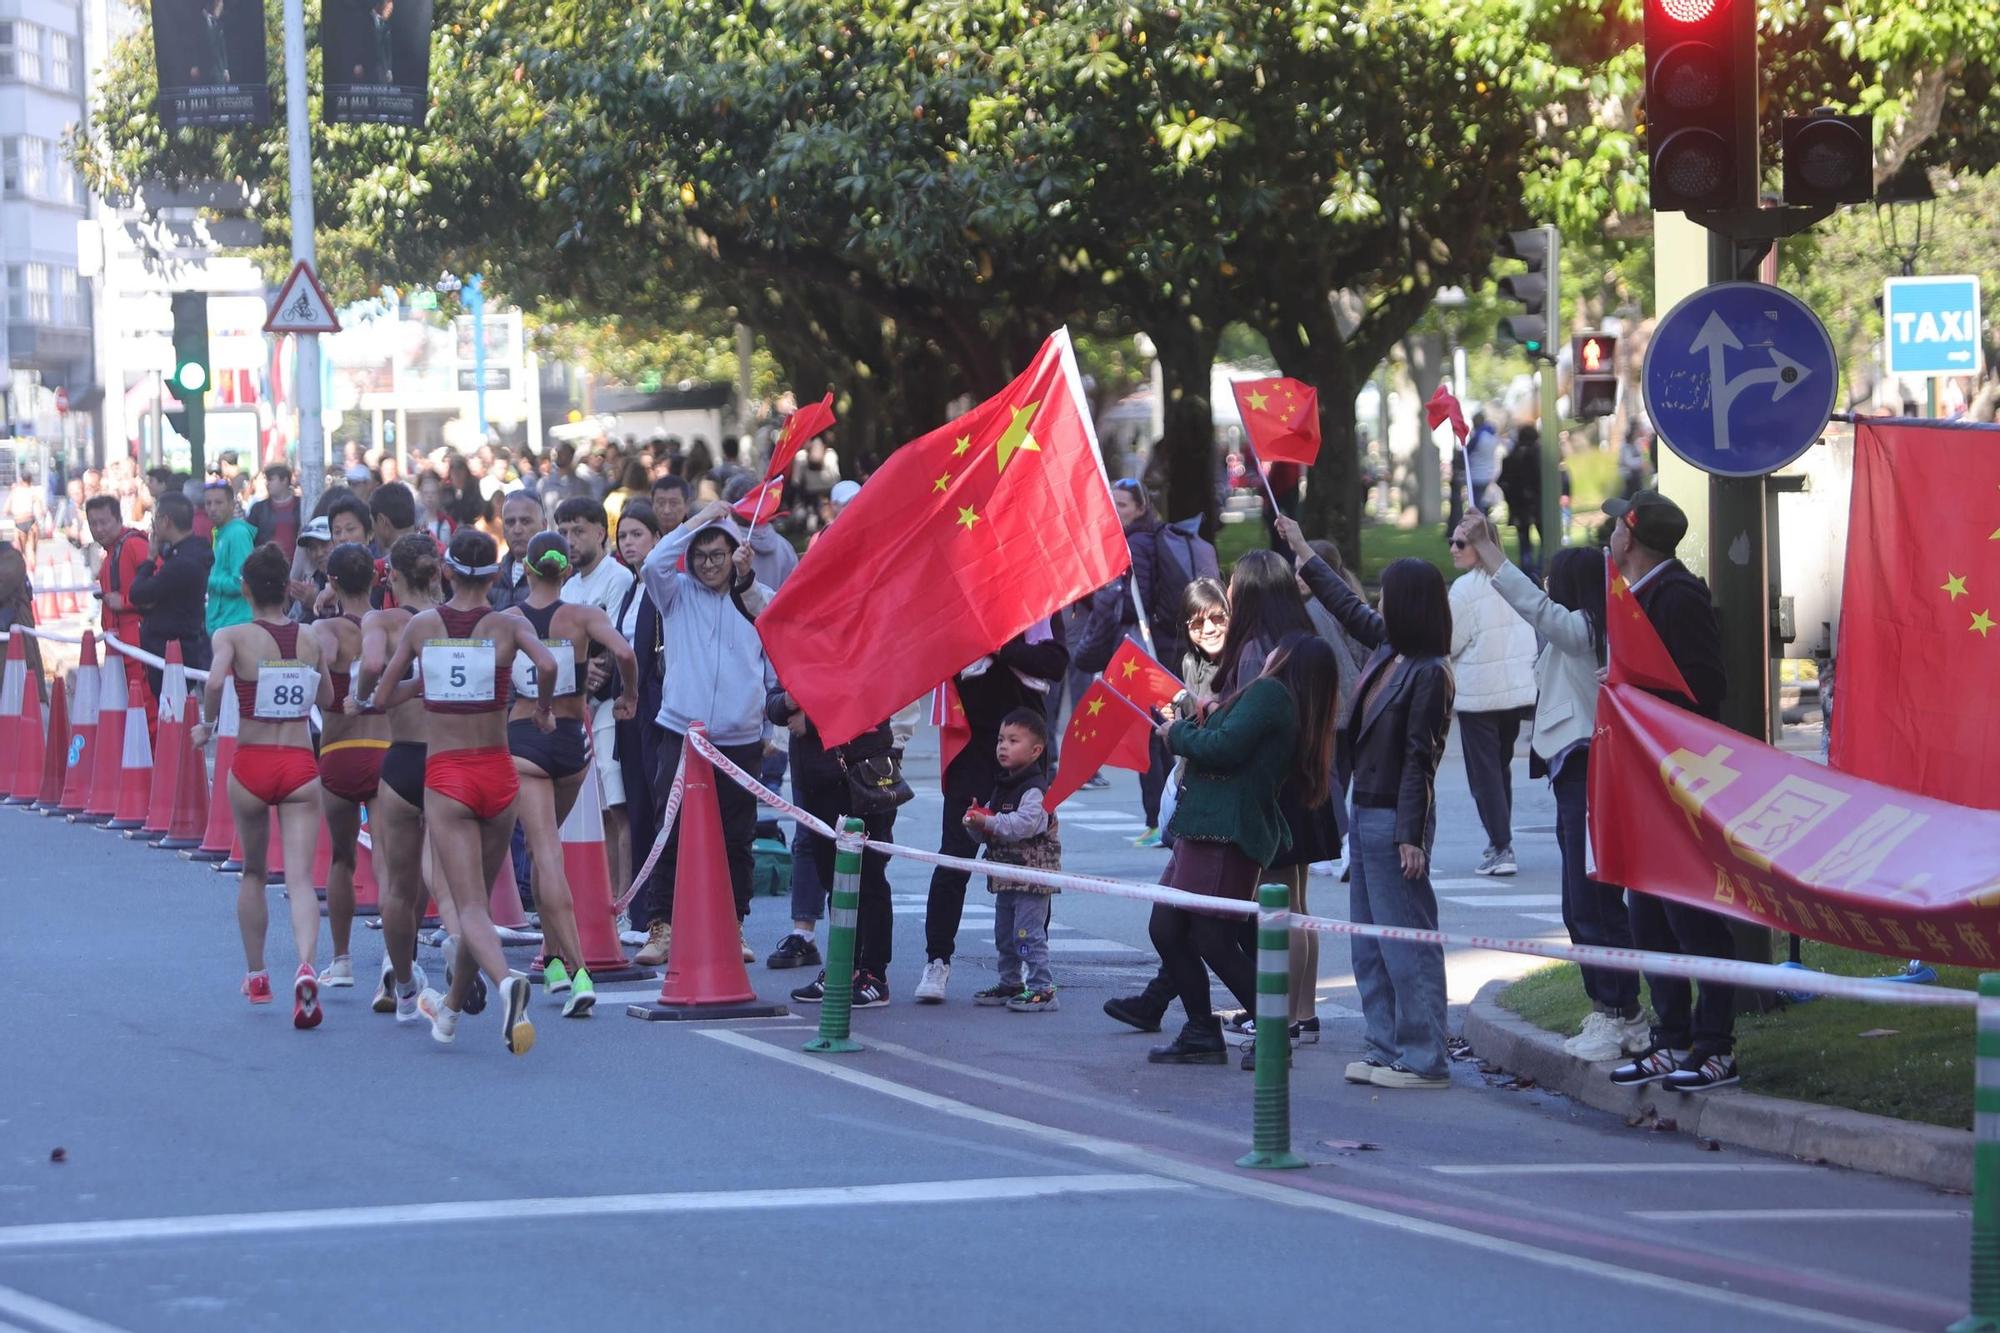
[{"xmin": 628, "ymin": 727, "xmax": 790, "ymax": 1023}]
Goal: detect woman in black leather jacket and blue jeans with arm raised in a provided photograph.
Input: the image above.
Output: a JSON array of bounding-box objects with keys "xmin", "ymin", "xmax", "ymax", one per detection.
[{"xmin": 1276, "ymin": 518, "xmax": 1452, "ymax": 1089}]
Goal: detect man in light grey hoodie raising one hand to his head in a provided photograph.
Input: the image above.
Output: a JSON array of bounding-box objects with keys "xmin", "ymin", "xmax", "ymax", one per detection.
[{"xmin": 632, "ymin": 500, "xmax": 778, "ymax": 967}]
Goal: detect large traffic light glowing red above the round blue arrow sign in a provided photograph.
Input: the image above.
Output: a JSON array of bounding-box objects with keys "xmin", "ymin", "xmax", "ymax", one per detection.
[{"xmin": 1644, "ymin": 0, "xmax": 1758, "ymax": 212}]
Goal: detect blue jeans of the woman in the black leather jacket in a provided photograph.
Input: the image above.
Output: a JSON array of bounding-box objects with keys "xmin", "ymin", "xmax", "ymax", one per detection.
[{"xmin": 1348, "ymin": 805, "xmax": 1446, "ymax": 1079}]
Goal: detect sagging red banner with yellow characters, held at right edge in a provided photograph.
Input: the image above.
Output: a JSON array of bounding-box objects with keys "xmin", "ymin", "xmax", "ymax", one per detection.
[{"xmin": 1590, "ymin": 685, "xmax": 2000, "ymax": 969}]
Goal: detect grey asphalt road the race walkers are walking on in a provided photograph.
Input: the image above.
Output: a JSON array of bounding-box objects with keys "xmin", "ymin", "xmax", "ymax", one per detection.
[{"xmin": 0, "ymin": 716, "xmax": 1968, "ymax": 1333}]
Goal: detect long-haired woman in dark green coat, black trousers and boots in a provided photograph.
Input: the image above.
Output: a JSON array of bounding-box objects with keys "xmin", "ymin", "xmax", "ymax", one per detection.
[{"xmin": 1146, "ymin": 634, "xmax": 1340, "ymax": 1065}]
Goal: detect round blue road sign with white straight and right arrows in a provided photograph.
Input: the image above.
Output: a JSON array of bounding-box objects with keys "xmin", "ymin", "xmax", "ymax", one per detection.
[{"xmin": 1642, "ymin": 282, "xmax": 1840, "ymax": 476}]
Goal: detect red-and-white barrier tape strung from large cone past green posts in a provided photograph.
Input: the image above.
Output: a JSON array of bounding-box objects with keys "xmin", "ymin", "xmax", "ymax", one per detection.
[{"xmin": 688, "ymin": 733, "xmax": 1978, "ymax": 1009}]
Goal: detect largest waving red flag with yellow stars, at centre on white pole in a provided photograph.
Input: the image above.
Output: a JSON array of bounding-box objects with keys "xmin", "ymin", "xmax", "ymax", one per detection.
[{"xmin": 756, "ymin": 330, "xmax": 1132, "ymax": 745}]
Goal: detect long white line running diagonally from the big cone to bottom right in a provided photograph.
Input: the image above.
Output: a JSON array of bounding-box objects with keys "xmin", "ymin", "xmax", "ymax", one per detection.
[{"xmin": 702, "ymin": 1027, "xmax": 1892, "ymax": 1333}]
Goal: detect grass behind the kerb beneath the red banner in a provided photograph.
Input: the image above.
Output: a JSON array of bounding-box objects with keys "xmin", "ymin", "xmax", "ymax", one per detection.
[{"xmin": 1500, "ymin": 941, "xmax": 1978, "ymax": 1129}]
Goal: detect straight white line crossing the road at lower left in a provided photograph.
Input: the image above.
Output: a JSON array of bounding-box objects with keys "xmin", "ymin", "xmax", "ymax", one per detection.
[{"xmin": 0, "ymin": 1173, "xmax": 1186, "ymax": 1248}]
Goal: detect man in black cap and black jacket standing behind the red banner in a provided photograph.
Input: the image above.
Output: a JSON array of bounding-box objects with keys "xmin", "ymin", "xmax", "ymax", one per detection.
[{"xmin": 1604, "ymin": 490, "xmax": 1736, "ymax": 1093}]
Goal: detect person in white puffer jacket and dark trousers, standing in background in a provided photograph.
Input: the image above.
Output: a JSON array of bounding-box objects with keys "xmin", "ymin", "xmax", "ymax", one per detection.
[{"xmin": 1452, "ymin": 512, "xmax": 1536, "ymax": 875}]
